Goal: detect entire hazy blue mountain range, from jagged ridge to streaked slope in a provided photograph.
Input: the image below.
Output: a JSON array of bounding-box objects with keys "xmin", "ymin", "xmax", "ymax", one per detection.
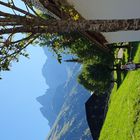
[{"xmin": 37, "ymin": 49, "xmax": 92, "ymax": 140}]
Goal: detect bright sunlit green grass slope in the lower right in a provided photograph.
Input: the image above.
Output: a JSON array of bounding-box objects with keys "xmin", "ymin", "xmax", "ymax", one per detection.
[{"xmin": 99, "ymin": 45, "xmax": 140, "ymax": 140}]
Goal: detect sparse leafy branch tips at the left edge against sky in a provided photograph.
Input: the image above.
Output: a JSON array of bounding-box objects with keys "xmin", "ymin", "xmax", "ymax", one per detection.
[{"xmin": 0, "ymin": 34, "xmax": 34, "ymax": 75}]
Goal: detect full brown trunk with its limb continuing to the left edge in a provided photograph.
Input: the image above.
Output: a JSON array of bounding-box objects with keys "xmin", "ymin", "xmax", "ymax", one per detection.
[{"xmin": 0, "ymin": 18, "xmax": 140, "ymax": 35}]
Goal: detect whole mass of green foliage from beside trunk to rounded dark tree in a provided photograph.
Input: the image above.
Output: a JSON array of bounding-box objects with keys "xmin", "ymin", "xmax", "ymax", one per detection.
[{"xmin": 40, "ymin": 33, "xmax": 114, "ymax": 92}]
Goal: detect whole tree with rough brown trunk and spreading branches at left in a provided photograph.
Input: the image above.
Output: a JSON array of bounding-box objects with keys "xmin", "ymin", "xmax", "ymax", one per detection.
[{"xmin": 0, "ymin": 0, "xmax": 140, "ymax": 70}]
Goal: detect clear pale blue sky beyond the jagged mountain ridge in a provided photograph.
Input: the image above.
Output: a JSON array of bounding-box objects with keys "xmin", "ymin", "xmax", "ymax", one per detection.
[{"xmin": 0, "ymin": 46, "xmax": 49, "ymax": 140}]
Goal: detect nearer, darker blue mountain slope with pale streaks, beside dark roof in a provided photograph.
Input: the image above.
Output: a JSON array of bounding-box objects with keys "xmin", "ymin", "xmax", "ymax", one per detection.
[{"xmin": 48, "ymin": 82, "xmax": 92, "ymax": 140}]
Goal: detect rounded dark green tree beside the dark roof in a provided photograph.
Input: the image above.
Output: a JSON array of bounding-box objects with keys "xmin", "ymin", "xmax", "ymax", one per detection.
[{"xmin": 78, "ymin": 64, "xmax": 111, "ymax": 93}]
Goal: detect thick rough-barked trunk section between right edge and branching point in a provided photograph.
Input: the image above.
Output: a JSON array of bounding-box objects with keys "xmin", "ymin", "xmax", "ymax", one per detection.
[{"xmin": 42, "ymin": 19, "xmax": 140, "ymax": 32}]
